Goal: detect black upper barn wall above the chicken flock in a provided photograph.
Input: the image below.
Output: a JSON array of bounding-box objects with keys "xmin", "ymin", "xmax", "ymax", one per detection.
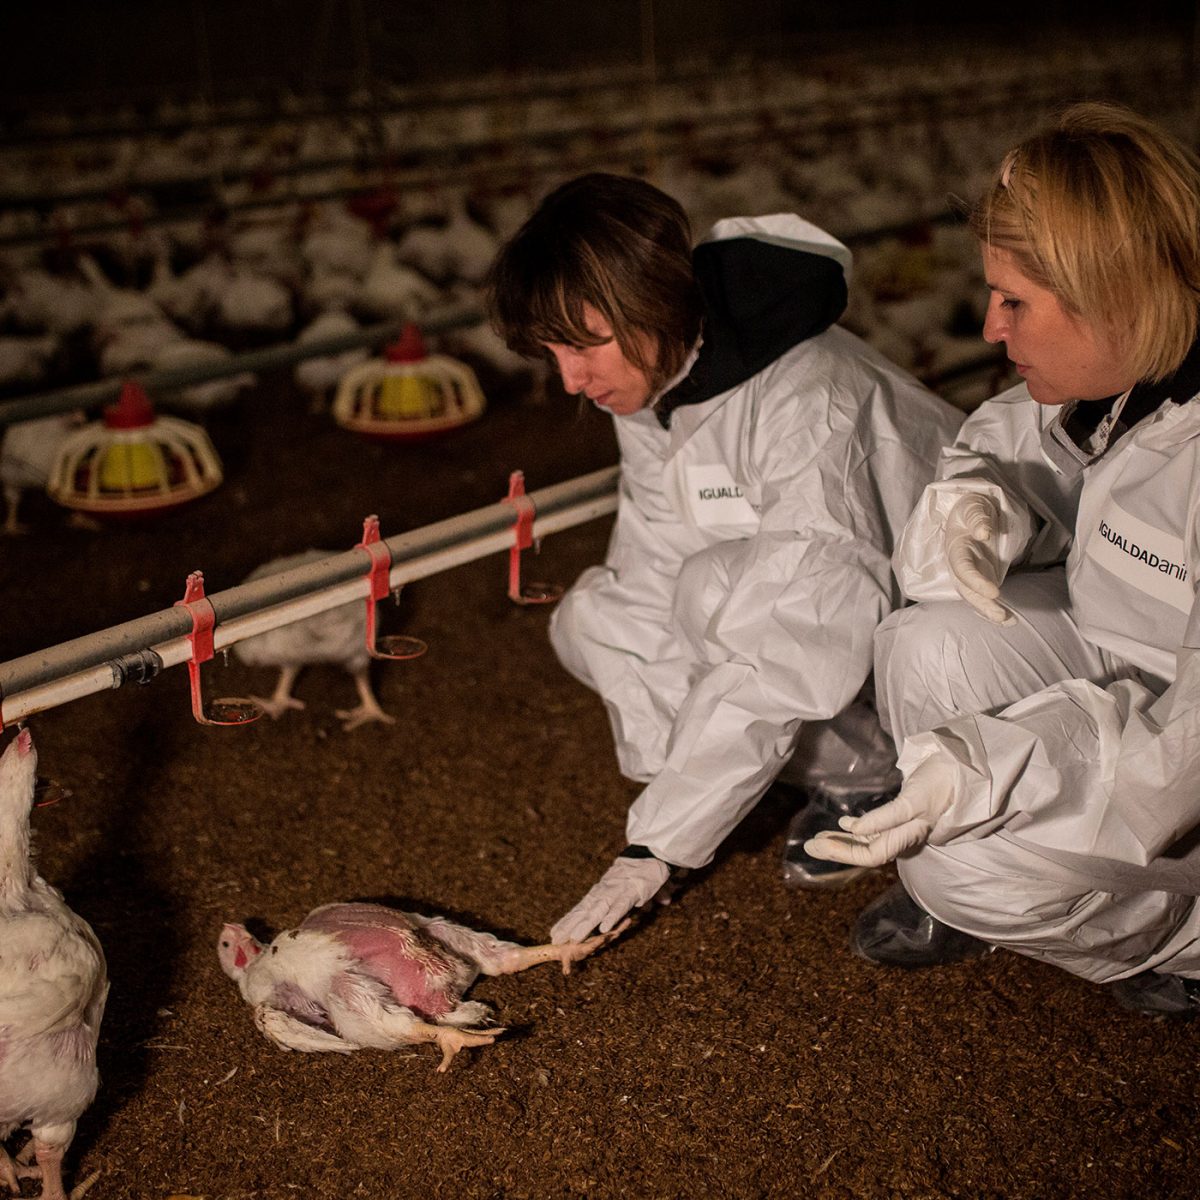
[{"xmin": 0, "ymin": 0, "xmax": 1196, "ymax": 109}]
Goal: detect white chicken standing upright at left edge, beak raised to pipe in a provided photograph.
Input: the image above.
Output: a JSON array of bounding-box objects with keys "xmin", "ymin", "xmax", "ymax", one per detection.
[{"xmin": 0, "ymin": 730, "xmax": 108, "ymax": 1200}]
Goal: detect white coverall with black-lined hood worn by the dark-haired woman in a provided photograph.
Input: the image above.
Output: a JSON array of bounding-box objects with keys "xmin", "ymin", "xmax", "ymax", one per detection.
[{"xmin": 551, "ymin": 215, "xmax": 961, "ymax": 868}]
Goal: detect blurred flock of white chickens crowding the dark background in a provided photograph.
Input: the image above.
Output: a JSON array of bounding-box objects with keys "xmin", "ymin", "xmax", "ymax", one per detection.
[{"xmin": 9, "ymin": 42, "xmax": 1171, "ymax": 415}]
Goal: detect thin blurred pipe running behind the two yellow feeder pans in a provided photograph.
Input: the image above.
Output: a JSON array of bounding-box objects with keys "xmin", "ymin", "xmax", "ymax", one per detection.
[{"xmin": 0, "ymin": 308, "xmax": 484, "ymax": 427}]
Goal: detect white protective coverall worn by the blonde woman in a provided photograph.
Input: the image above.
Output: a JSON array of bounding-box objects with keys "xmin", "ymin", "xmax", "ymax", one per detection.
[{"xmin": 876, "ymin": 362, "xmax": 1200, "ymax": 983}]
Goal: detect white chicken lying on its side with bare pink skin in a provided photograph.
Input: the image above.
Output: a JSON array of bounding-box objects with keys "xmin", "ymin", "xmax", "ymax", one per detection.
[{"xmin": 217, "ymin": 904, "xmax": 628, "ymax": 1072}]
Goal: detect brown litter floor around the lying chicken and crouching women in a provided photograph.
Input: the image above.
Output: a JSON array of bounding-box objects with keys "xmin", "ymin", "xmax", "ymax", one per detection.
[{"xmin": 0, "ymin": 376, "xmax": 1200, "ymax": 1200}]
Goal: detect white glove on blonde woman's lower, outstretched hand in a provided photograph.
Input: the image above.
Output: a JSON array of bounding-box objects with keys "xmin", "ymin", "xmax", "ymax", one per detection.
[{"xmin": 804, "ymin": 755, "xmax": 955, "ymax": 866}]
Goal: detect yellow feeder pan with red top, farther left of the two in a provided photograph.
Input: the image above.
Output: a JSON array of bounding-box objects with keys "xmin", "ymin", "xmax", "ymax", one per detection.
[{"xmin": 46, "ymin": 382, "xmax": 222, "ymax": 516}]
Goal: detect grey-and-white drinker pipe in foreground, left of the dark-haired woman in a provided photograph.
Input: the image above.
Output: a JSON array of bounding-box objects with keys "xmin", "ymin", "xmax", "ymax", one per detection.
[{"xmin": 0, "ymin": 467, "xmax": 620, "ymax": 725}]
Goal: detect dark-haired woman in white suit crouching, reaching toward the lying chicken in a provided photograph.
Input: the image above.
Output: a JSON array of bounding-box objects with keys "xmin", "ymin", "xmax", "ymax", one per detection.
[{"xmin": 490, "ymin": 174, "xmax": 960, "ymax": 942}]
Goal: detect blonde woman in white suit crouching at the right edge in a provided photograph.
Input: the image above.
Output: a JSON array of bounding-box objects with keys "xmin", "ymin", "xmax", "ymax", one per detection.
[{"xmin": 808, "ymin": 104, "xmax": 1200, "ymax": 1016}]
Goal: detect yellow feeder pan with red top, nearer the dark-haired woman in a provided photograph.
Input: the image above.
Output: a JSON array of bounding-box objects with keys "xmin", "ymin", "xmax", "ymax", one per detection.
[{"xmin": 334, "ymin": 325, "xmax": 487, "ymax": 442}]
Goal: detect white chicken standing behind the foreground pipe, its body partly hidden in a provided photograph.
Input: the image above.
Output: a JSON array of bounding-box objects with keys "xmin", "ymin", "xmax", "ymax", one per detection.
[{"xmin": 234, "ymin": 550, "xmax": 396, "ymax": 732}]
